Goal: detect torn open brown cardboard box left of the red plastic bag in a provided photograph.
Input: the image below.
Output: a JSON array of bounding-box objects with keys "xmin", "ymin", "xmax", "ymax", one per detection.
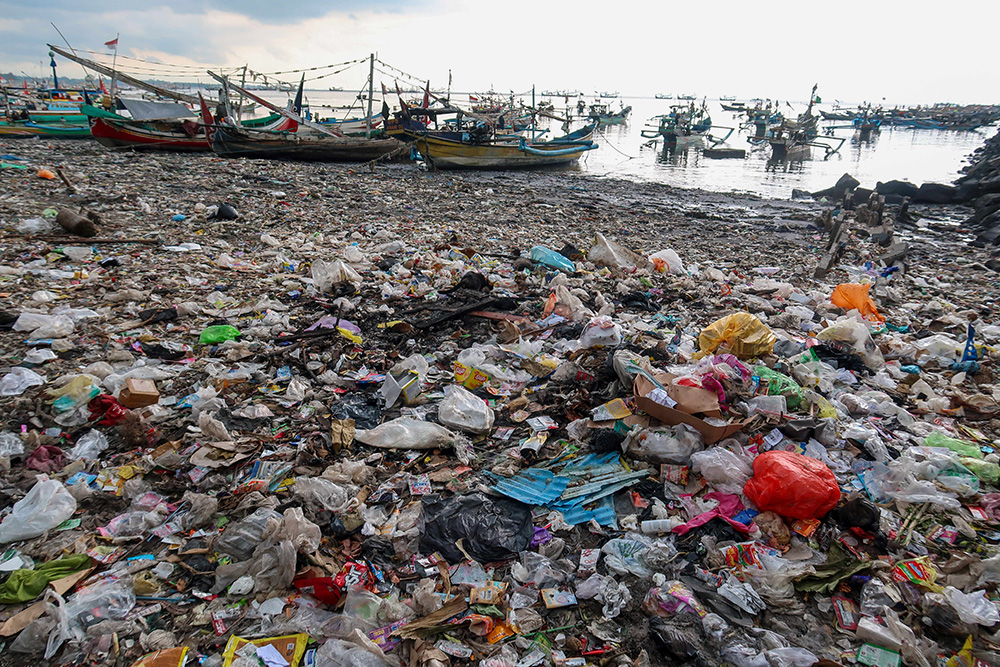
[{"xmin": 632, "ymin": 372, "xmax": 749, "ymax": 445}]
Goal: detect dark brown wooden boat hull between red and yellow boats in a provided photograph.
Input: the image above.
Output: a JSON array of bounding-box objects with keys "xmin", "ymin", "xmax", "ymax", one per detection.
[{"xmin": 212, "ymin": 128, "xmax": 401, "ymax": 162}]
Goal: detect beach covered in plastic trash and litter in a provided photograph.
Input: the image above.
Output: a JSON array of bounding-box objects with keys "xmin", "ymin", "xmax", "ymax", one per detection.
[{"xmin": 0, "ymin": 137, "xmax": 1000, "ymax": 667}]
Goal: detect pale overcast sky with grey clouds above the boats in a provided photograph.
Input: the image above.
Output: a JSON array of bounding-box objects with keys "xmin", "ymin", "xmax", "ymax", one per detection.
[{"xmin": 0, "ymin": 0, "xmax": 1000, "ymax": 104}]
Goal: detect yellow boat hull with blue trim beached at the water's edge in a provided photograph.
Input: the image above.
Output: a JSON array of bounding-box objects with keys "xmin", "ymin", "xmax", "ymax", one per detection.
[{"xmin": 415, "ymin": 124, "xmax": 598, "ymax": 169}]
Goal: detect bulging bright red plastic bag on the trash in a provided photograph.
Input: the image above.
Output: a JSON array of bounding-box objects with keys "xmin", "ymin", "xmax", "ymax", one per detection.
[{"xmin": 743, "ymin": 451, "xmax": 840, "ymax": 519}]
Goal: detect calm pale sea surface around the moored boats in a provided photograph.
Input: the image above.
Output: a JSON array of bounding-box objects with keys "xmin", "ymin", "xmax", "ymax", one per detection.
[{"xmin": 252, "ymin": 91, "xmax": 996, "ymax": 198}]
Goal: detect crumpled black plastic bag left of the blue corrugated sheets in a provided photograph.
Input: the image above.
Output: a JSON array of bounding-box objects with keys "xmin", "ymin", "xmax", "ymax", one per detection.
[{"xmin": 420, "ymin": 493, "xmax": 534, "ymax": 563}]
